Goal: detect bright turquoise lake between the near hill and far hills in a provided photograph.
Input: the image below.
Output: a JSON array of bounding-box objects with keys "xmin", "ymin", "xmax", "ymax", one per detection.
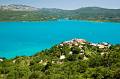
[{"xmin": 0, "ymin": 20, "xmax": 120, "ymax": 58}]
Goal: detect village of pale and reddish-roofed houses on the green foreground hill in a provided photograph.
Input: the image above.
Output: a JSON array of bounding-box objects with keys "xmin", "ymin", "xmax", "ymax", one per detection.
[{"xmin": 29, "ymin": 38, "xmax": 111, "ymax": 65}]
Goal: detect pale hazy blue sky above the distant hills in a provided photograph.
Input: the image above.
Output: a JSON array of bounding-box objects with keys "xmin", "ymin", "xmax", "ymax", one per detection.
[{"xmin": 0, "ymin": 0, "xmax": 120, "ymax": 9}]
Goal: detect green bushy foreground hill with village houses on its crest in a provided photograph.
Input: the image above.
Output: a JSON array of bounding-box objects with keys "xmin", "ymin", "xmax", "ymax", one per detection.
[{"xmin": 0, "ymin": 39, "xmax": 120, "ymax": 79}]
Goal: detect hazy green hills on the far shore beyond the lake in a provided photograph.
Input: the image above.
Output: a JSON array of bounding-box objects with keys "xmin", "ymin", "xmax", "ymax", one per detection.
[{"xmin": 0, "ymin": 4, "xmax": 120, "ymax": 22}]
